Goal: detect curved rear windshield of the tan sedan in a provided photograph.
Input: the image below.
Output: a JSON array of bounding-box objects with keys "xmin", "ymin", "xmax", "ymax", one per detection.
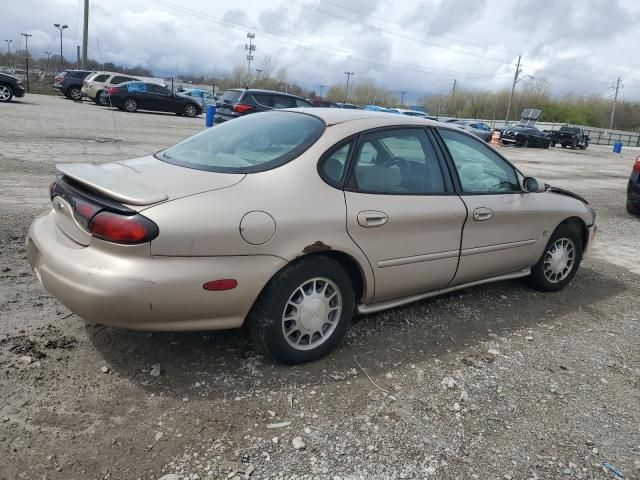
[{"xmin": 156, "ymin": 111, "xmax": 325, "ymax": 173}]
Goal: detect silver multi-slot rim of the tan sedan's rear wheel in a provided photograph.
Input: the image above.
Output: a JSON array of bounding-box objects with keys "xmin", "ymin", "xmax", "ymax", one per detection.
[{"xmin": 282, "ymin": 277, "xmax": 342, "ymax": 350}]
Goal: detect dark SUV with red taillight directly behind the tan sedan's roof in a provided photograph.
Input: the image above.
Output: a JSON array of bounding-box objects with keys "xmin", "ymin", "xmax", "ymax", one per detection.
[{"xmin": 215, "ymin": 88, "xmax": 313, "ymax": 123}]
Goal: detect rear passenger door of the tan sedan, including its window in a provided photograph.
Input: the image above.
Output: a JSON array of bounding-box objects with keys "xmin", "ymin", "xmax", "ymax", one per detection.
[{"xmin": 345, "ymin": 127, "xmax": 466, "ymax": 301}]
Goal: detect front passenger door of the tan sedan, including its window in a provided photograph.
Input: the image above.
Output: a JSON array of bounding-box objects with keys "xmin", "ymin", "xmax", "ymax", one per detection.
[{"xmin": 437, "ymin": 128, "xmax": 545, "ymax": 285}]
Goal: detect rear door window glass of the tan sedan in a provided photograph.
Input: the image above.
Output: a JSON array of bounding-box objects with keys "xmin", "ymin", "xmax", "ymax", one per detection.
[{"xmin": 354, "ymin": 129, "xmax": 445, "ymax": 194}]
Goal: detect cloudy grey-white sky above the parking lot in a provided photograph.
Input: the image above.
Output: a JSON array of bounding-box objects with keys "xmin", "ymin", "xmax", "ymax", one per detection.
[{"xmin": 0, "ymin": 0, "xmax": 640, "ymax": 101}]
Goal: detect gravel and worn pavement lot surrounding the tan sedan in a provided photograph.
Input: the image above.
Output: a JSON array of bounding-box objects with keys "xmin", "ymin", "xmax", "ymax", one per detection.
[{"xmin": 0, "ymin": 95, "xmax": 640, "ymax": 480}]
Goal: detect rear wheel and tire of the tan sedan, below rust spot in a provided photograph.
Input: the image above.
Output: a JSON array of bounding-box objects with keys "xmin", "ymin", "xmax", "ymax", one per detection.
[{"xmin": 247, "ymin": 256, "xmax": 355, "ymax": 365}]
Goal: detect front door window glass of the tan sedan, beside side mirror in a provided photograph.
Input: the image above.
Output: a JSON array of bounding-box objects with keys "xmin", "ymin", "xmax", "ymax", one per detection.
[{"xmin": 439, "ymin": 129, "xmax": 520, "ymax": 193}]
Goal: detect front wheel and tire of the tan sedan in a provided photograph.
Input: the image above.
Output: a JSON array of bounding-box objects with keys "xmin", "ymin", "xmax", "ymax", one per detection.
[{"xmin": 527, "ymin": 224, "xmax": 583, "ymax": 292}]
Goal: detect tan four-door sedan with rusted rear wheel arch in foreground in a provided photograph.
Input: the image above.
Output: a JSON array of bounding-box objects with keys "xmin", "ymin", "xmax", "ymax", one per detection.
[{"xmin": 26, "ymin": 108, "xmax": 595, "ymax": 364}]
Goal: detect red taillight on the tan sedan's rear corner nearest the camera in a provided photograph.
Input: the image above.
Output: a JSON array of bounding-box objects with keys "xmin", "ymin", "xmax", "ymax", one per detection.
[{"xmin": 89, "ymin": 212, "xmax": 158, "ymax": 244}]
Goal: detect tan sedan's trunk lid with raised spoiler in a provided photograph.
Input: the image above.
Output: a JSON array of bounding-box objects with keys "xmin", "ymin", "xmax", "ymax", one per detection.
[{"xmin": 50, "ymin": 156, "xmax": 246, "ymax": 245}]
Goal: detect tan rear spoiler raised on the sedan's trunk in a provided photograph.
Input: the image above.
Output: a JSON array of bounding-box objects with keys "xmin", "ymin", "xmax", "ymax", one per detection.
[{"xmin": 56, "ymin": 163, "xmax": 169, "ymax": 205}]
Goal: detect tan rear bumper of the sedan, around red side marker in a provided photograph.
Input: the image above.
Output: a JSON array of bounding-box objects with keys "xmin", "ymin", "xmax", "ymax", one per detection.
[{"xmin": 27, "ymin": 212, "xmax": 286, "ymax": 330}]
